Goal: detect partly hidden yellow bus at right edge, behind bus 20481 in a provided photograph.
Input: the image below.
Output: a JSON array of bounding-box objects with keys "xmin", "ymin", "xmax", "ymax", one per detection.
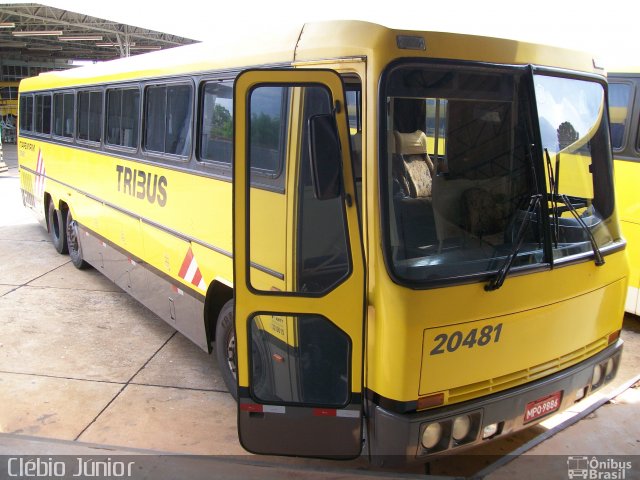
[{"xmin": 608, "ymin": 67, "xmax": 640, "ymax": 315}]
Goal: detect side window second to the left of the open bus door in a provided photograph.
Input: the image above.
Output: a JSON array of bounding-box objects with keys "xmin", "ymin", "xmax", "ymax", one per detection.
[{"xmin": 144, "ymin": 85, "xmax": 193, "ymax": 157}]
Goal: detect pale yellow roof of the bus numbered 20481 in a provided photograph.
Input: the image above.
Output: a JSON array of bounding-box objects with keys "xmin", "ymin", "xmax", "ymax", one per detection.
[{"xmin": 20, "ymin": 20, "xmax": 602, "ymax": 91}]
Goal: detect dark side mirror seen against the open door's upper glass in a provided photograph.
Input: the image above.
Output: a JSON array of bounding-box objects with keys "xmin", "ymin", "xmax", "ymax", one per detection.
[{"xmin": 308, "ymin": 114, "xmax": 342, "ymax": 200}]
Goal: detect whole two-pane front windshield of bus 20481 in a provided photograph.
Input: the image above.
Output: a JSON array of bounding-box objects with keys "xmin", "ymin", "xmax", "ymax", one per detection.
[{"xmin": 381, "ymin": 63, "xmax": 613, "ymax": 284}]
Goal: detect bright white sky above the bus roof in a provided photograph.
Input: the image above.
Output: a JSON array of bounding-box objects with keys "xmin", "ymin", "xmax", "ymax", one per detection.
[{"xmin": 27, "ymin": 0, "xmax": 640, "ymax": 68}]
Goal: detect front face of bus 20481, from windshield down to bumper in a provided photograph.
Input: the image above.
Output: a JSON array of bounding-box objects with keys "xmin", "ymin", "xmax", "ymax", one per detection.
[{"xmin": 366, "ymin": 59, "xmax": 626, "ymax": 458}]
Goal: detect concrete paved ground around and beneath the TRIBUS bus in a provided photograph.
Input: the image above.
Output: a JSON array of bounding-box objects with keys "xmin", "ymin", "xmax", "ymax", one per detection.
[{"xmin": 0, "ymin": 146, "xmax": 640, "ymax": 479}]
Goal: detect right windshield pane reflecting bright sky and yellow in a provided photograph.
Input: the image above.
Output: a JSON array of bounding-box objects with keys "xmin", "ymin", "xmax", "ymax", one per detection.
[{"xmin": 534, "ymin": 75, "xmax": 613, "ymax": 259}]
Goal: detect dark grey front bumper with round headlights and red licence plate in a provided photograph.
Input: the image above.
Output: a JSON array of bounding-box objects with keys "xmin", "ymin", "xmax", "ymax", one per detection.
[{"xmin": 367, "ymin": 340, "xmax": 623, "ymax": 465}]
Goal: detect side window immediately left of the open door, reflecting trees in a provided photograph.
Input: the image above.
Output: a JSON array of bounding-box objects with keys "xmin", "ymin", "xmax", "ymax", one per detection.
[{"xmin": 199, "ymin": 81, "xmax": 233, "ymax": 164}]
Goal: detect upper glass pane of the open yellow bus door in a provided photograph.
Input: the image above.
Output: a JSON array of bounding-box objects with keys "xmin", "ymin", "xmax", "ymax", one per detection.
[{"xmin": 249, "ymin": 86, "xmax": 350, "ymax": 294}]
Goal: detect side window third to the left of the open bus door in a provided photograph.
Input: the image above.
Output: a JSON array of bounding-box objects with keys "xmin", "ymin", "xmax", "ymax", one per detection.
[{"xmin": 106, "ymin": 88, "xmax": 140, "ymax": 148}]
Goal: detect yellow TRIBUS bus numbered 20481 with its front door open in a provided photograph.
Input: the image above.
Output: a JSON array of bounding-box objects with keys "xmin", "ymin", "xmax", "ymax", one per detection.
[{"xmin": 18, "ymin": 21, "xmax": 628, "ymax": 464}]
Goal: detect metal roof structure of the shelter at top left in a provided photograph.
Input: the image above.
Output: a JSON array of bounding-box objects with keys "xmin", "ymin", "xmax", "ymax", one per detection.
[{"xmin": 0, "ymin": 3, "xmax": 196, "ymax": 63}]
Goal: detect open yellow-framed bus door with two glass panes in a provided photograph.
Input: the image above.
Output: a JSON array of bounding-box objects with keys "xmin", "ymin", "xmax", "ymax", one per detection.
[{"xmin": 233, "ymin": 70, "xmax": 365, "ymax": 458}]
